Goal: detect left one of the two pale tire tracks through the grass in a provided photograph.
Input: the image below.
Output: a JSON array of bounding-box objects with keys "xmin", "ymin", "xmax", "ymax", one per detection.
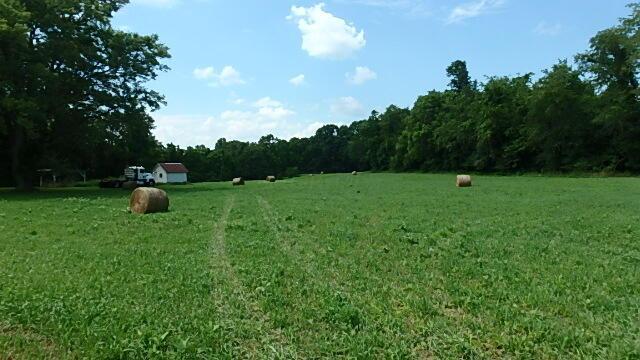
[{"xmin": 211, "ymin": 195, "xmax": 297, "ymax": 359}]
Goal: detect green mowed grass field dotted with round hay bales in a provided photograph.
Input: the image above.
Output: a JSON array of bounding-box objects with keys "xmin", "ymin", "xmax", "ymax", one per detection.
[{"xmin": 0, "ymin": 173, "xmax": 640, "ymax": 359}]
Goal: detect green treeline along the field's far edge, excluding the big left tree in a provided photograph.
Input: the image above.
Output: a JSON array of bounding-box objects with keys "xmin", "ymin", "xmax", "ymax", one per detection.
[{"xmin": 160, "ymin": 4, "xmax": 640, "ymax": 181}]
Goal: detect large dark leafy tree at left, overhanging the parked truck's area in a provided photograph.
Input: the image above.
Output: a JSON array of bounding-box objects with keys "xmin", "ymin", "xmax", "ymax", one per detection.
[{"xmin": 0, "ymin": 0, "xmax": 169, "ymax": 188}]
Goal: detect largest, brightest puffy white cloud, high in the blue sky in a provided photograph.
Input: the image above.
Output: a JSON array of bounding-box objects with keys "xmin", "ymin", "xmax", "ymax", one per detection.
[{"xmin": 287, "ymin": 3, "xmax": 367, "ymax": 59}]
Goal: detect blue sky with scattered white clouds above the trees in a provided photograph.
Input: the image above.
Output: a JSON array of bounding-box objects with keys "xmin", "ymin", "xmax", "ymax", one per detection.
[{"xmin": 113, "ymin": 0, "xmax": 630, "ymax": 147}]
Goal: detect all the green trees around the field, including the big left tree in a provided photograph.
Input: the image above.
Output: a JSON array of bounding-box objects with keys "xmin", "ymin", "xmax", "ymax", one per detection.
[{"xmin": 0, "ymin": 1, "xmax": 640, "ymax": 185}]
